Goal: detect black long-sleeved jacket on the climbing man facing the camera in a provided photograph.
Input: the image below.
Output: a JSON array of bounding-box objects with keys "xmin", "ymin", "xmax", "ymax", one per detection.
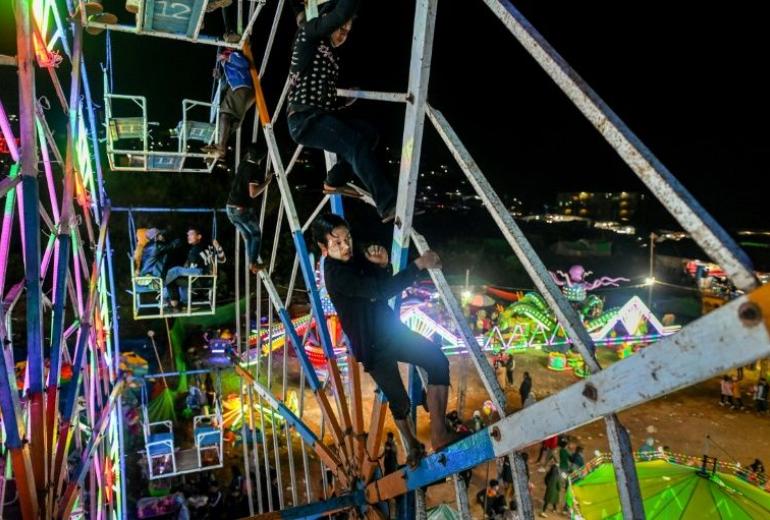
[{"xmin": 324, "ymin": 255, "xmax": 420, "ymax": 371}]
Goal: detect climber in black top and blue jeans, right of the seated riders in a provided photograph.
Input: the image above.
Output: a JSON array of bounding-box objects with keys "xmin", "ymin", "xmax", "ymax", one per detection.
[{"xmin": 225, "ymin": 144, "xmax": 272, "ymax": 274}]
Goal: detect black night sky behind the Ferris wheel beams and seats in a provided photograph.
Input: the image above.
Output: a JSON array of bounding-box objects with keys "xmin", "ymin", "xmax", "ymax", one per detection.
[{"xmin": 0, "ymin": 0, "xmax": 770, "ymax": 227}]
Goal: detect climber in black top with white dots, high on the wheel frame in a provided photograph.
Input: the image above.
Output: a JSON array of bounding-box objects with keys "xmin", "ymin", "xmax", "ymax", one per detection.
[{"xmin": 287, "ymin": 0, "xmax": 396, "ymax": 222}]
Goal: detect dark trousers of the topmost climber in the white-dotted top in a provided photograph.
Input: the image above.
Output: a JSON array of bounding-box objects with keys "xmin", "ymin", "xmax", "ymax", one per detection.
[{"xmin": 289, "ymin": 110, "xmax": 396, "ymax": 215}]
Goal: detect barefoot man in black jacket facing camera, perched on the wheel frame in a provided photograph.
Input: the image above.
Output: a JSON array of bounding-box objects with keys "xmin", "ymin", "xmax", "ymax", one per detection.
[{"xmin": 313, "ymin": 214, "xmax": 453, "ymax": 465}]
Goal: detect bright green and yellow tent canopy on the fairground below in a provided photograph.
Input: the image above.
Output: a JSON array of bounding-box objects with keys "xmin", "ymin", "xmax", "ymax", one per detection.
[{"xmin": 568, "ymin": 460, "xmax": 770, "ymax": 520}]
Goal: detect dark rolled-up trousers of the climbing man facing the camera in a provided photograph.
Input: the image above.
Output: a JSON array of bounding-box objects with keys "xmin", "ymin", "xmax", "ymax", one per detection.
[{"xmin": 367, "ymin": 327, "xmax": 449, "ymax": 419}]
